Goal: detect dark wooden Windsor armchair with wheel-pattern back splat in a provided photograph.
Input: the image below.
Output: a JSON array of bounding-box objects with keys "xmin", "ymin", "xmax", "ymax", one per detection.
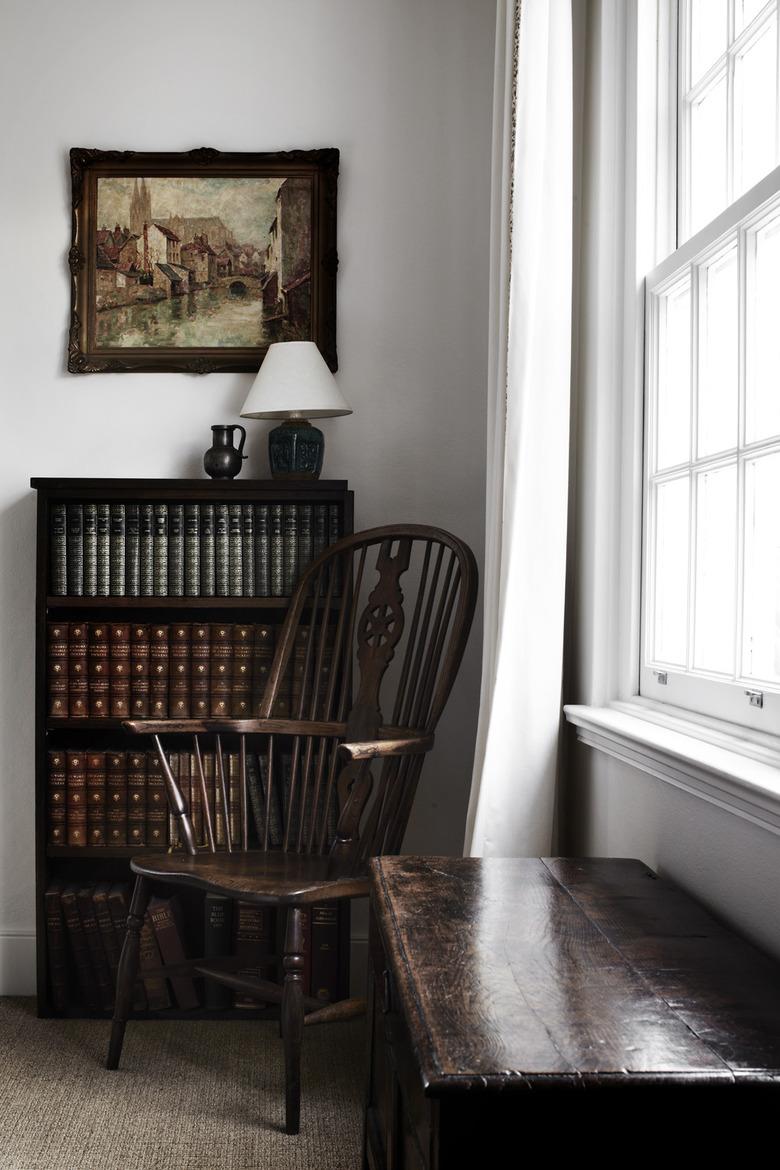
[{"xmin": 106, "ymin": 524, "xmax": 477, "ymax": 1134}]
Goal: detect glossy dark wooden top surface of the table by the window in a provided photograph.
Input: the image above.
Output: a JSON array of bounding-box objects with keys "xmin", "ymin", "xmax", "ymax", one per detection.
[{"xmin": 372, "ymin": 856, "xmax": 780, "ymax": 1094}]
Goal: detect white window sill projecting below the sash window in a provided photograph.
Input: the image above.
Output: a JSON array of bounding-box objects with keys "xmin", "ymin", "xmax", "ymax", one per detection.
[{"xmin": 564, "ymin": 701, "xmax": 780, "ymax": 834}]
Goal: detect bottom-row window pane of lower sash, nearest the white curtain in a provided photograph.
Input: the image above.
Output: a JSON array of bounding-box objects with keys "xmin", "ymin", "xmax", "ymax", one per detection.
[{"xmin": 653, "ymin": 477, "xmax": 690, "ymax": 666}]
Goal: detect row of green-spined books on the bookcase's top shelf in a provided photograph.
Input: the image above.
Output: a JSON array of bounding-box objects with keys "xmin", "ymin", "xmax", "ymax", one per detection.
[{"xmin": 49, "ymin": 502, "xmax": 343, "ymax": 597}]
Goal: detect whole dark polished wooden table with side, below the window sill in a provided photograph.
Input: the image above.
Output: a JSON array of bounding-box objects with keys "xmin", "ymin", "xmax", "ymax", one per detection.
[{"xmin": 366, "ymin": 856, "xmax": 780, "ymax": 1170}]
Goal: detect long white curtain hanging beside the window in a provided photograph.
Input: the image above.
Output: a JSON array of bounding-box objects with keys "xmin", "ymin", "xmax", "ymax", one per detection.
[{"xmin": 465, "ymin": 0, "xmax": 573, "ymax": 856}]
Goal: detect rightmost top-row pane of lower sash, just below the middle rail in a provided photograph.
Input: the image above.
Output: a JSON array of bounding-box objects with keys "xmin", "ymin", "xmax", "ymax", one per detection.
[{"xmin": 745, "ymin": 219, "xmax": 780, "ymax": 442}]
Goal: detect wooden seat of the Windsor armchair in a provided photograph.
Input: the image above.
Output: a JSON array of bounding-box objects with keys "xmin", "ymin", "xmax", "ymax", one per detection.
[{"xmin": 130, "ymin": 851, "xmax": 368, "ymax": 906}]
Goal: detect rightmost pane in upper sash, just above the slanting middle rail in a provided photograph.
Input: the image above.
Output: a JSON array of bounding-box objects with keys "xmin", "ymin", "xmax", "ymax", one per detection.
[{"xmin": 734, "ymin": 18, "xmax": 778, "ymax": 198}]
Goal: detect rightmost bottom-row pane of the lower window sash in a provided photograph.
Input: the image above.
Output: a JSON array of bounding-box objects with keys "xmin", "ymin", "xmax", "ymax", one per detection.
[{"xmin": 743, "ymin": 454, "xmax": 780, "ymax": 684}]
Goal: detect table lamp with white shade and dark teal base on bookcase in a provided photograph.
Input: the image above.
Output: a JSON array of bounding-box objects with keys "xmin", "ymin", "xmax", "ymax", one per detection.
[{"xmin": 241, "ymin": 342, "xmax": 352, "ymax": 480}]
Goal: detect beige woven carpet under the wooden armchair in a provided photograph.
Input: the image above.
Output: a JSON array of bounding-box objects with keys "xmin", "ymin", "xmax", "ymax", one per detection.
[{"xmin": 0, "ymin": 999, "xmax": 365, "ymax": 1170}]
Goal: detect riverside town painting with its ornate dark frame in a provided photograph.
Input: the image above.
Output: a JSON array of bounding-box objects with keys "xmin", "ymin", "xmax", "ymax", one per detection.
[{"xmin": 68, "ymin": 147, "xmax": 339, "ymax": 373}]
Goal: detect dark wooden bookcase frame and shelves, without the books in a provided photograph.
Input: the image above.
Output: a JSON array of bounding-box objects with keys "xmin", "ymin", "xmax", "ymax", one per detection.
[{"xmin": 30, "ymin": 479, "xmax": 354, "ymax": 1019}]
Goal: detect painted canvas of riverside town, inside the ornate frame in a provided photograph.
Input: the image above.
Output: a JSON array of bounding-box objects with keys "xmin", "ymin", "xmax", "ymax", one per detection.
[{"xmin": 95, "ymin": 177, "xmax": 311, "ymax": 349}]
